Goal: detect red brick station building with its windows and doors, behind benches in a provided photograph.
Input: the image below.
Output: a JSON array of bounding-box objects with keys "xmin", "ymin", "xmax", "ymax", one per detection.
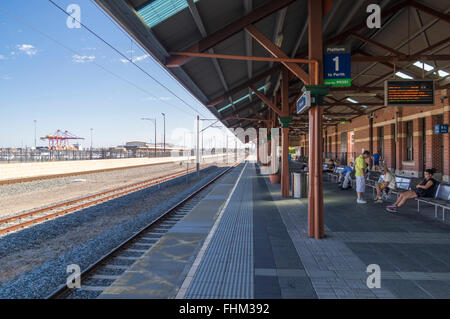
[{"xmin": 299, "ymin": 90, "xmax": 450, "ymax": 181}]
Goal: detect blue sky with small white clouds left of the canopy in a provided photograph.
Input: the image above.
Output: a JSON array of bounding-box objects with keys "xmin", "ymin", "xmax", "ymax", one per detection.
[{"xmin": 0, "ymin": 0, "xmax": 218, "ymax": 147}]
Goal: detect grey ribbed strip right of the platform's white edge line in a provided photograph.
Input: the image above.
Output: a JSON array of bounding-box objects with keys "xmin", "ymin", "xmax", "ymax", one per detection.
[{"xmin": 185, "ymin": 164, "xmax": 255, "ymax": 299}]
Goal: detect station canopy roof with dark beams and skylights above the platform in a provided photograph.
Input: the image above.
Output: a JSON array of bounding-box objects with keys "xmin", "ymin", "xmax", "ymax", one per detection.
[{"xmin": 96, "ymin": 0, "xmax": 450, "ymax": 136}]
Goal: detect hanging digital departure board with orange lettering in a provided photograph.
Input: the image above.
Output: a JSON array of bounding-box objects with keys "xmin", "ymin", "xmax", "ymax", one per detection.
[{"xmin": 384, "ymin": 80, "xmax": 434, "ymax": 106}]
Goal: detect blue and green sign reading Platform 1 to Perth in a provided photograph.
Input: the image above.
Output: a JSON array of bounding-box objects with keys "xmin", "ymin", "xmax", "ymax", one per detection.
[{"xmin": 323, "ymin": 45, "xmax": 352, "ymax": 86}]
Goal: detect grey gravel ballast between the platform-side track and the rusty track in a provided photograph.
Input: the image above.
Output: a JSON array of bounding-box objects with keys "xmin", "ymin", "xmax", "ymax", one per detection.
[{"xmin": 0, "ymin": 167, "xmax": 229, "ymax": 298}]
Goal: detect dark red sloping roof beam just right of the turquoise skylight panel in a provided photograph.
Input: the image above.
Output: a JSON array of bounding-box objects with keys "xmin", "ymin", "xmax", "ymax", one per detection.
[{"xmin": 166, "ymin": 0, "xmax": 295, "ymax": 67}]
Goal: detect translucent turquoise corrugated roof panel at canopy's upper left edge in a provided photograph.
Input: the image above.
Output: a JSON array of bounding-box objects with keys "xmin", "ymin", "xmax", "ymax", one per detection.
[{"xmin": 138, "ymin": 0, "xmax": 198, "ymax": 28}]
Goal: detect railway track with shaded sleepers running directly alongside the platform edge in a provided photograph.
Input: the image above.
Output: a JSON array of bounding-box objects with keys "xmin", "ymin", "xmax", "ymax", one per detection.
[{"xmin": 47, "ymin": 163, "xmax": 238, "ymax": 299}]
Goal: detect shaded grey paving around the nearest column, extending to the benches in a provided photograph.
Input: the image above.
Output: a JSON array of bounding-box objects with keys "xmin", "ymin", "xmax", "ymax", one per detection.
[{"xmin": 268, "ymin": 171, "xmax": 450, "ymax": 298}]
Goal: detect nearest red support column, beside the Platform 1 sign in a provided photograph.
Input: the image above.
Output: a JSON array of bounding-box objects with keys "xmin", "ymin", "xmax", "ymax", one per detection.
[{"xmin": 308, "ymin": 0, "xmax": 325, "ymax": 239}]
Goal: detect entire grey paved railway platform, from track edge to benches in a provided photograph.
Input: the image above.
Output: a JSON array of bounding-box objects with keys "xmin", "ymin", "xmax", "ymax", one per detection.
[{"xmin": 99, "ymin": 162, "xmax": 450, "ymax": 299}]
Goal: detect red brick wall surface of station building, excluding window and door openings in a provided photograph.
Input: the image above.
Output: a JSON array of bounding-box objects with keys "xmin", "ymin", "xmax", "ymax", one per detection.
[{"xmin": 294, "ymin": 90, "xmax": 450, "ymax": 181}]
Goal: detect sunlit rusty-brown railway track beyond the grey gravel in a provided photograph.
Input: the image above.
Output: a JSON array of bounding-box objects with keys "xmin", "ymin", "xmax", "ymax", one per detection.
[{"xmin": 0, "ymin": 165, "xmax": 213, "ymax": 235}]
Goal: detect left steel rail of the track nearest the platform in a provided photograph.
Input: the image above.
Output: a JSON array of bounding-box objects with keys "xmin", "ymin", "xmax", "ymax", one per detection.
[{"xmin": 45, "ymin": 162, "xmax": 240, "ymax": 299}]
